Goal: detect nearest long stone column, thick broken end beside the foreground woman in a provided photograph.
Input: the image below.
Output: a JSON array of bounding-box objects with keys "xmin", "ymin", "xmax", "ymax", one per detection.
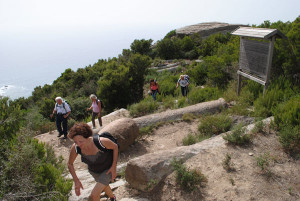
[{"xmin": 125, "ymin": 118, "xmax": 272, "ymax": 192}]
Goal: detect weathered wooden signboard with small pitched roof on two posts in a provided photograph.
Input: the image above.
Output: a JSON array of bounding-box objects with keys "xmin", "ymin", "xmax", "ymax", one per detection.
[{"xmin": 232, "ymin": 27, "xmax": 286, "ymax": 94}]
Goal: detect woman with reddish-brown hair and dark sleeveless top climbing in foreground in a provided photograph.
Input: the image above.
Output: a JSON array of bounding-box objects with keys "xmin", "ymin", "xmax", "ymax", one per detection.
[{"xmin": 68, "ymin": 123, "xmax": 118, "ymax": 201}]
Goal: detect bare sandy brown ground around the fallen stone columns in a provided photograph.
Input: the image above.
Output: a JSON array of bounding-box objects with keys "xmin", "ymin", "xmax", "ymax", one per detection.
[{"xmin": 38, "ymin": 106, "xmax": 300, "ymax": 201}]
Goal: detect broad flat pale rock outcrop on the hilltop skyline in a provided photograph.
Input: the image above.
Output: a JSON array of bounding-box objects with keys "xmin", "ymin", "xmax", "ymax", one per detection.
[{"xmin": 176, "ymin": 22, "xmax": 245, "ymax": 37}]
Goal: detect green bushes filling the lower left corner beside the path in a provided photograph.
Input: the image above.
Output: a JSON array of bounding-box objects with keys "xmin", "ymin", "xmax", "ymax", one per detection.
[{"xmin": 0, "ymin": 98, "xmax": 72, "ymax": 200}]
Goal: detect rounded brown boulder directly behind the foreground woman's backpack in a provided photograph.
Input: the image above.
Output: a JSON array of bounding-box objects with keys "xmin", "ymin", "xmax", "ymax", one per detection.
[{"xmin": 99, "ymin": 118, "xmax": 139, "ymax": 151}]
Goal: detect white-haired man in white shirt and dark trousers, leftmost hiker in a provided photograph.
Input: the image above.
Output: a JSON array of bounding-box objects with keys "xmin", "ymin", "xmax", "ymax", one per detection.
[{"xmin": 50, "ymin": 97, "xmax": 71, "ymax": 139}]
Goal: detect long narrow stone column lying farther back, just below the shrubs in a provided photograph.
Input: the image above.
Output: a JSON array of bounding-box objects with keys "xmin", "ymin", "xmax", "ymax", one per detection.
[{"xmin": 133, "ymin": 98, "xmax": 226, "ymax": 128}]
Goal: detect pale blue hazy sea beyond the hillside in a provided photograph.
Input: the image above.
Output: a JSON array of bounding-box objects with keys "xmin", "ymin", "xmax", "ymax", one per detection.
[{"xmin": 0, "ymin": 27, "xmax": 172, "ymax": 100}]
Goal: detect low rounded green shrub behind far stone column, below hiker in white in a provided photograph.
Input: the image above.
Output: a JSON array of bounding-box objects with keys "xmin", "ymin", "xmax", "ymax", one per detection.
[{"xmin": 188, "ymin": 87, "xmax": 219, "ymax": 104}]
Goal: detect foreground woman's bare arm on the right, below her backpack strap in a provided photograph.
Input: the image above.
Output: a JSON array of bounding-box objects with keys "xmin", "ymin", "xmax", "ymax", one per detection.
[{"xmin": 101, "ymin": 137, "xmax": 119, "ymax": 181}]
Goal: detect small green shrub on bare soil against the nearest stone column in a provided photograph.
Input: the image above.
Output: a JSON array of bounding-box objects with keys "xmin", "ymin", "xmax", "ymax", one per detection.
[{"xmin": 172, "ymin": 159, "xmax": 207, "ymax": 192}]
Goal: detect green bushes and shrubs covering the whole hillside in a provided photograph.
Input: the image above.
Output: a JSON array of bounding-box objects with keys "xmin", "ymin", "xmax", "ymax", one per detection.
[{"xmin": 0, "ymin": 17, "xmax": 300, "ymax": 200}]
